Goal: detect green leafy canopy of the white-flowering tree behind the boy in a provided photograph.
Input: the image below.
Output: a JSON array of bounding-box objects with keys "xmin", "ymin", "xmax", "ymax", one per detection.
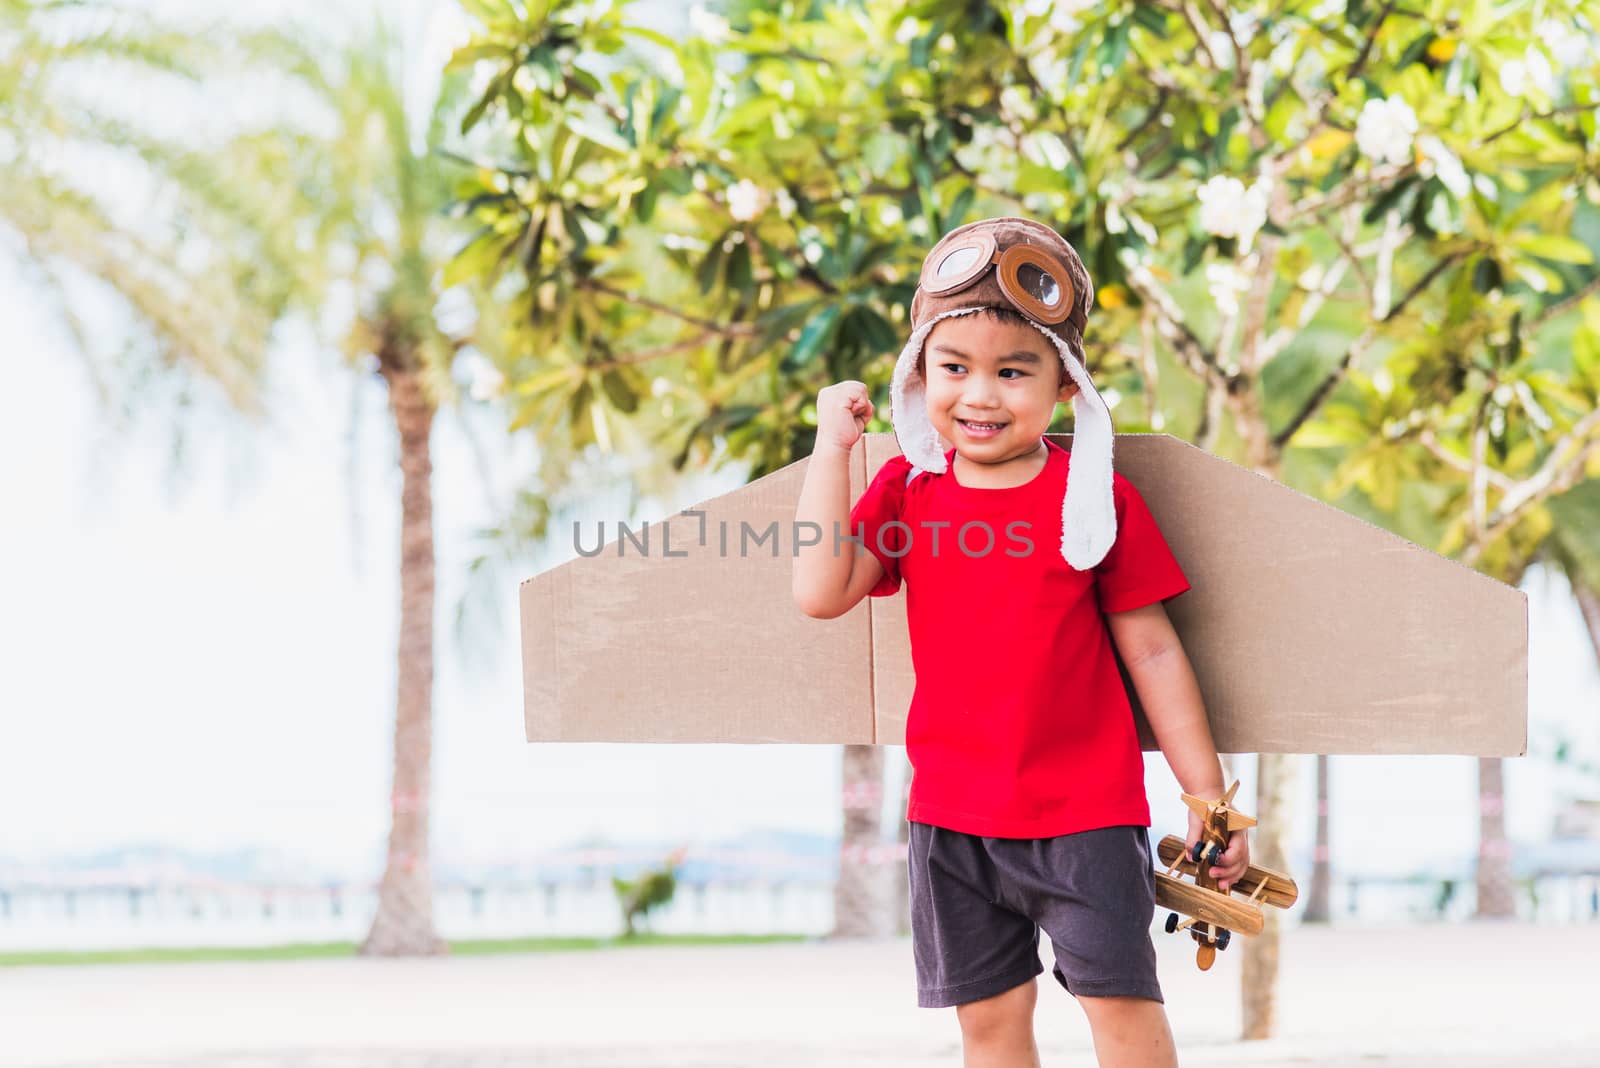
[{"xmin": 432, "ymin": 0, "xmax": 1600, "ymax": 585}]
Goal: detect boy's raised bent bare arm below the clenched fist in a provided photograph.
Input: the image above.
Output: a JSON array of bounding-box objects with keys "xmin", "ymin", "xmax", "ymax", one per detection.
[{"xmin": 792, "ymin": 441, "xmax": 883, "ymax": 619}]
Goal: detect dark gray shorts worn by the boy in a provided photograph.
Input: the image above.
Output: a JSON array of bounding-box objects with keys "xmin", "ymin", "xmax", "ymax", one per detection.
[{"xmin": 907, "ymin": 823, "xmax": 1162, "ymax": 1009}]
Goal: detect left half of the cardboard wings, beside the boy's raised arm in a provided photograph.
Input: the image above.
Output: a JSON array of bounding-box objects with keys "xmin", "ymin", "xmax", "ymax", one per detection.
[{"xmin": 520, "ymin": 443, "xmax": 872, "ymax": 743}]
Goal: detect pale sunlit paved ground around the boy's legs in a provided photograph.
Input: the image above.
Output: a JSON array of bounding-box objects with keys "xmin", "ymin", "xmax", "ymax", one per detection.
[{"xmin": 0, "ymin": 924, "xmax": 1600, "ymax": 1068}]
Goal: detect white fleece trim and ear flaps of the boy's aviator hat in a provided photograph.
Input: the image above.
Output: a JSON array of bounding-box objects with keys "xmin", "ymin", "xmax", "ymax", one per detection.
[{"xmin": 890, "ymin": 309, "xmax": 1117, "ymax": 571}]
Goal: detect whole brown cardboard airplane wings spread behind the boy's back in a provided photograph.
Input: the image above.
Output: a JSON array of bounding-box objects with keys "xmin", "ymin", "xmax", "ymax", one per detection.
[{"xmin": 520, "ymin": 433, "xmax": 1528, "ymax": 756}]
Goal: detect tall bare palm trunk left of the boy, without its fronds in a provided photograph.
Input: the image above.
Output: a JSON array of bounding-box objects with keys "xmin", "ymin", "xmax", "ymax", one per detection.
[{"xmin": 360, "ymin": 362, "xmax": 448, "ymax": 956}]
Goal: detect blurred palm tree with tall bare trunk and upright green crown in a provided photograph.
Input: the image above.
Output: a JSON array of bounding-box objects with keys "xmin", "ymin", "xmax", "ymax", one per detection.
[{"xmin": 240, "ymin": 19, "xmax": 491, "ymax": 956}]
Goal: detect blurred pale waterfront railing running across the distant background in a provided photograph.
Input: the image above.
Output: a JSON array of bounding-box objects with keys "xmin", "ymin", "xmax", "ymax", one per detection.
[{"xmin": 0, "ymin": 865, "xmax": 1600, "ymax": 951}]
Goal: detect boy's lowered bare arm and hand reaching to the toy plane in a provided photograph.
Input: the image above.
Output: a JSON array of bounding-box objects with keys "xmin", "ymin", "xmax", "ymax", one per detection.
[{"xmin": 1106, "ymin": 601, "xmax": 1250, "ymax": 891}]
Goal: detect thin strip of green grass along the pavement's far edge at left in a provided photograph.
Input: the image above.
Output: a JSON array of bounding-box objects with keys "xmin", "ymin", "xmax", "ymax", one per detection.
[{"xmin": 0, "ymin": 934, "xmax": 813, "ymax": 967}]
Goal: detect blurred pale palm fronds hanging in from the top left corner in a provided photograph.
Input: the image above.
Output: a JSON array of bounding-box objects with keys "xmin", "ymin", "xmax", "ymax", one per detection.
[{"xmin": 0, "ymin": 0, "xmax": 298, "ymax": 433}]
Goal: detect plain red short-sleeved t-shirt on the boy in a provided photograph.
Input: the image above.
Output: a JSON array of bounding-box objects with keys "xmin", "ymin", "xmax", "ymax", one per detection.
[{"xmin": 850, "ymin": 438, "xmax": 1189, "ymax": 838}]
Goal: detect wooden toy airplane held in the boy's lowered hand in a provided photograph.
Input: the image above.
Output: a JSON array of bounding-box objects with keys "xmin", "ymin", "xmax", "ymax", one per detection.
[{"xmin": 1155, "ymin": 779, "xmax": 1299, "ymax": 972}]
